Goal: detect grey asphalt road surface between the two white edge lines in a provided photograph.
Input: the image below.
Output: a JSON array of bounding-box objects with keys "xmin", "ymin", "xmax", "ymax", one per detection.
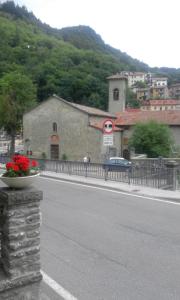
[{"xmin": 37, "ymin": 178, "xmax": 180, "ymax": 300}]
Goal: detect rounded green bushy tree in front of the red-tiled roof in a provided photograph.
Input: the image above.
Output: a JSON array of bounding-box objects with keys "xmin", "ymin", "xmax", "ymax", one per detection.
[{"xmin": 129, "ymin": 121, "xmax": 173, "ymax": 157}]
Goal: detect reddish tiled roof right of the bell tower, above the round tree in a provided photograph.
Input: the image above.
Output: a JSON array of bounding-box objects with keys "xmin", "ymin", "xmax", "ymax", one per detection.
[{"xmin": 115, "ymin": 110, "xmax": 180, "ymax": 126}]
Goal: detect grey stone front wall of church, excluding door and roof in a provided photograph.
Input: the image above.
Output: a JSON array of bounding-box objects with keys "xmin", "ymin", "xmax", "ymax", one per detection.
[{"xmin": 23, "ymin": 98, "xmax": 116, "ymax": 162}]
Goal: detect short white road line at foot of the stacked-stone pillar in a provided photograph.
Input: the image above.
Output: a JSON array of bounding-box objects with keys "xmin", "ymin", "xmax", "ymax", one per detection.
[{"xmin": 41, "ymin": 270, "xmax": 78, "ymax": 300}]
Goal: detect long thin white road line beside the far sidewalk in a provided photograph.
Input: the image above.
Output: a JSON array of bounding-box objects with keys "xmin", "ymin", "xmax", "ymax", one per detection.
[{"xmin": 41, "ymin": 176, "xmax": 180, "ymax": 205}]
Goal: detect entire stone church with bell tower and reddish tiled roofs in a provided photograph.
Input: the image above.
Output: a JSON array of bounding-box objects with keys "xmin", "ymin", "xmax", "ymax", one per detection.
[{"xmin": 23, "ymin": 74, "xmax": 180, "ymax": 162}]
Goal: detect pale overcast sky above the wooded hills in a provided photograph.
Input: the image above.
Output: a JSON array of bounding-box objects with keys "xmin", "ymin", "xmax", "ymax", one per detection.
[{"xmin": 8, "ymin": 0, "xmax": 180, "ymax": 68}]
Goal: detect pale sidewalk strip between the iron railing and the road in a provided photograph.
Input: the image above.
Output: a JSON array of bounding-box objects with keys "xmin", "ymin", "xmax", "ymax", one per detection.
[{"xmin": 41, "ymin": 171, "xmax": 180, "ymax": 202}]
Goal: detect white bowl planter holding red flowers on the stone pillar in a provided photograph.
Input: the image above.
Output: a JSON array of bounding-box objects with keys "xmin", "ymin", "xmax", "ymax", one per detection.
[{"xmin": 0, "ymin": 173, "xmax": 39, "ymax": 189}]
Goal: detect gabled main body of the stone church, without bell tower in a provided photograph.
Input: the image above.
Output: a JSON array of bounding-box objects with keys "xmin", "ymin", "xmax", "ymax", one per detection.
[{"xmin": 23, "ymin": 95, "xmax": 121, "ymax": 162}]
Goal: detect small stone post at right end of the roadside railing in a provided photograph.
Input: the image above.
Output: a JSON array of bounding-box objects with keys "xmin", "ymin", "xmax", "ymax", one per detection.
[{"xmin": 165, "ymin": 160, "xmax": 178, "ymax": 191}]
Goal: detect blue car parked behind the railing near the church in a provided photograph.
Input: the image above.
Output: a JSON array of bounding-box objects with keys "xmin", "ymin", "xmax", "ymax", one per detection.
[{"xmin": 103, "ymin": 157, "xmax": 132, "ymax": 172}]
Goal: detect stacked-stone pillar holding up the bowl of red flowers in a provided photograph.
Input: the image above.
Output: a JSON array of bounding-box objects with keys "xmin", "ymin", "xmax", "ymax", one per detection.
[{"xmin": 0, "ymin": 188, "xmax": 42, "ymax": 300}]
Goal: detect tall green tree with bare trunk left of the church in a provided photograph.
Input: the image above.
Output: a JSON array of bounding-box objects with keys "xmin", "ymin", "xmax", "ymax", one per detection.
[{"xmin": 0, "ymin": 72, "xmax": 36, "ymax": 155}]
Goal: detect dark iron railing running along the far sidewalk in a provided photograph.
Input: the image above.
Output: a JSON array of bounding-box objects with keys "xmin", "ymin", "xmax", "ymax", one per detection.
[{"xmin": 0, "ymin": 157, "xmax": 180, "ymax": 190}]
